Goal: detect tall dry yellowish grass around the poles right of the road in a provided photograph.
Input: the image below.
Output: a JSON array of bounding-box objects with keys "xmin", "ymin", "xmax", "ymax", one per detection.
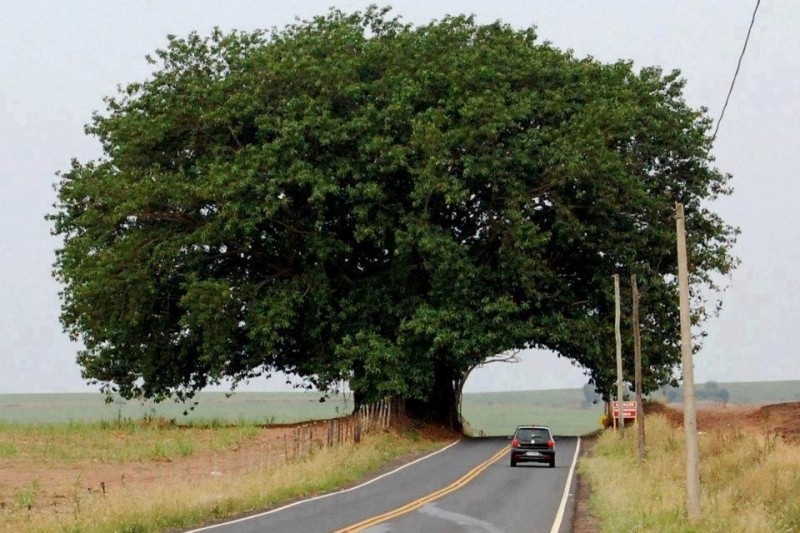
[{"xmin": 579, "ymin": 415, "xmax": 800, "ymax": 533}]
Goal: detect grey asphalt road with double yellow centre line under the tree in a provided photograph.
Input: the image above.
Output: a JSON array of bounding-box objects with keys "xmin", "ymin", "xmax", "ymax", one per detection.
[{"xmin": 188, "ymin": 437, "xmax": 578, "ymax": 533}]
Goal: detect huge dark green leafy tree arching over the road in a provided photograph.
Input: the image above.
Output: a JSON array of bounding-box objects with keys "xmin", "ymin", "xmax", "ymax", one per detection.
[{"xmin": 50, "ymin": 9, "xmax": 735, "ymax": 424}]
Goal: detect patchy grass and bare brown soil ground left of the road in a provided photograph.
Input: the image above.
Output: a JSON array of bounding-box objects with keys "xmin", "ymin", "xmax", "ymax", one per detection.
[{"xmin": 0, "ymin": 422, "xmax": 452, "ymax": 533}]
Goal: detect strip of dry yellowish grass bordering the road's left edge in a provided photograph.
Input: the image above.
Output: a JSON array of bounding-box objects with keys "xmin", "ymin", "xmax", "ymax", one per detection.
[{"xmin": 0, "ymin": 432, "xmax": 441, "ymax": 533}]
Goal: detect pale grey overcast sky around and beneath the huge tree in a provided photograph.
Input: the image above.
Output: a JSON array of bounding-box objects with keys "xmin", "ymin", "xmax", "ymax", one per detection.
[{"xmin": 0, "ymin": 0, "xmax": 800, "ymax": 394}]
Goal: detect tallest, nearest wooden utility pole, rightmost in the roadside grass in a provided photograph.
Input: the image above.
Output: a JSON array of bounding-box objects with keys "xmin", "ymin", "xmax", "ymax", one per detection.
[{"xmin": 675, "ymin": 204, "xmax": 700, "ymax": 521}]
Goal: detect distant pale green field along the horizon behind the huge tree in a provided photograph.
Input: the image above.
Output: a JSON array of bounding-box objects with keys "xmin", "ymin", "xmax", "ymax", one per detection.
[{"xmin": 0, "ymin": 381, "xmax": 800, "ymax": 436}]
